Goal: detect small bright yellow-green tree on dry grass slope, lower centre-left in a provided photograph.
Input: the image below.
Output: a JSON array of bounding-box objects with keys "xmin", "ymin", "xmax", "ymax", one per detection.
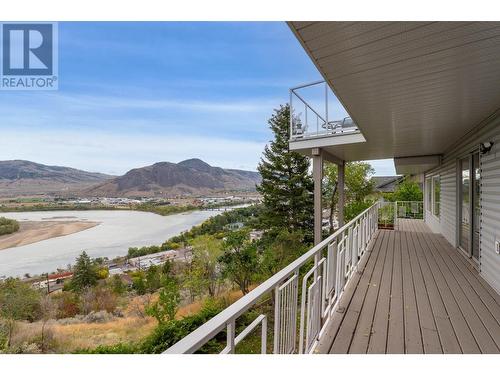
[{"xmin": 145, "ymin": 277, "xmax": 181, "ymax": 324}]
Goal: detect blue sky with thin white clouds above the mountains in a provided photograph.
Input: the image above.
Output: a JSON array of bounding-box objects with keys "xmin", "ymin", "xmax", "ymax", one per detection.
[{"xmin": 0, "ymin": 22, "xmax": 394, "ymax": 175}]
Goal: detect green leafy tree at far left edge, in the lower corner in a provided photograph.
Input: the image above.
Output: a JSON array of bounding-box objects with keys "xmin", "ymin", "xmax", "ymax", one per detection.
[{"xmin": 0, "ymin": 278, "xmax": 40, "ymax": 347}]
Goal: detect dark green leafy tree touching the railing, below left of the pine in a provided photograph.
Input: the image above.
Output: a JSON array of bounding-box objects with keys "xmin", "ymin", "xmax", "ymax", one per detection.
[{"xmin": 219, "ymin": 230, "xmax": 259, "ymax": 294}]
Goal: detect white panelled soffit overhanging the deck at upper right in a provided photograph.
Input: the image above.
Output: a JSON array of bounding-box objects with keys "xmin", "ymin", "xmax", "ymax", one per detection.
[{"xmin": 289, "ymin": 22, "xmax": 500, "ymax": 160}]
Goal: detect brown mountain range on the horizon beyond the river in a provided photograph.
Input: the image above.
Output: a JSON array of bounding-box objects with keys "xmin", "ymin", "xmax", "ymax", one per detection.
[{"xmin": 0, "ymin": 159, "xmax": 260, "ymax": 197}]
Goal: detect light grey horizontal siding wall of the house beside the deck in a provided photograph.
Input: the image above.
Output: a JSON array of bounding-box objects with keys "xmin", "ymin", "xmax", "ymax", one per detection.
[{"xmin": 424, "ymin": 114, "xmax": 500, "ymax": 292}]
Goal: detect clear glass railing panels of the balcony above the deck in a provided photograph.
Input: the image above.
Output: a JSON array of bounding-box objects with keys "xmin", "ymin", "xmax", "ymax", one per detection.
[{"xmin": 290, "ymin": 81, "xmax": 359, "ymax": 141}]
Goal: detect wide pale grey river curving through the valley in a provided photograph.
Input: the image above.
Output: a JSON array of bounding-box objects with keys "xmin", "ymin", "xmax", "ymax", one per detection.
[{"xmin": 0, "ymin": 210, "xmax": 221, "ymax": 276}]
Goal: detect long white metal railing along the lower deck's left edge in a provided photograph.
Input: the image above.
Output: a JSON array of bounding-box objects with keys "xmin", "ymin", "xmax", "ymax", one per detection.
[{"xmin": 165, "ymin": 203, "xmax": 380, "ymax": 354}]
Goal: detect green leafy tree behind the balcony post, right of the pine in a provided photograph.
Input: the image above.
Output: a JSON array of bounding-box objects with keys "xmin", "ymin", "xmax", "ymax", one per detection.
[{"xmin": 323, "ymin": 162, "xmax": 375, "ymax": 230}]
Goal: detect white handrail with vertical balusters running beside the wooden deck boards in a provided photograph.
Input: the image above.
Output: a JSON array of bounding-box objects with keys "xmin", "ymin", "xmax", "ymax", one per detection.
[{"xmin": 164, "ymin": 202, "xmax": 379, "ymax": 354}]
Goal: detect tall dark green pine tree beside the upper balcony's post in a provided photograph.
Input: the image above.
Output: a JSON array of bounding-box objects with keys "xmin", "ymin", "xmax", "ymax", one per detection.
[{"xmin": 257, "ymin": 105, "xmax": 314, "ymax": 239}]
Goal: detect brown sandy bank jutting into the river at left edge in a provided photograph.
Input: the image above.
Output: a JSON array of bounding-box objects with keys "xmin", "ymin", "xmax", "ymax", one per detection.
[{"xmin": 0, "ymin": 221, "xmax": 99, "ymax": 250}]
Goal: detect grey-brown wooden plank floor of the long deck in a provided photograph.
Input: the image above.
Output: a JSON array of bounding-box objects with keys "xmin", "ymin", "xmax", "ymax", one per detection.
[{"xmin": 316, "ymin": 220, "xmax": 500, "ymax": 354}]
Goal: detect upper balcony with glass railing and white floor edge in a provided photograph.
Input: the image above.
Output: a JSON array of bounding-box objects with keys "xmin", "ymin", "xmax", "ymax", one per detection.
[{"xmin": 290, "ymin": 81, "xmax": 365, "ymax": 153}]
